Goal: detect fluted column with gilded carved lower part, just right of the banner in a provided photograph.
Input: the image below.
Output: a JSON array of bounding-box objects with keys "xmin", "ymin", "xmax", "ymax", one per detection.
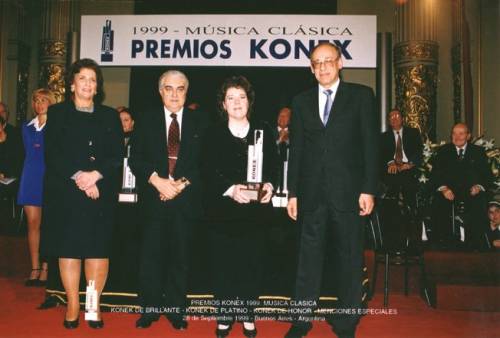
[{"xmin": 394, "ymin": 0, "xmax": 438, "ymax": 140}]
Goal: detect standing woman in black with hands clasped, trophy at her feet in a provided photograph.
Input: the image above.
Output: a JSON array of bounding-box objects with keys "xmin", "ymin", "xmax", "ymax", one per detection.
[{"xmin": 41, "ymin": 59, "xmax": 123, "ymax": 329}]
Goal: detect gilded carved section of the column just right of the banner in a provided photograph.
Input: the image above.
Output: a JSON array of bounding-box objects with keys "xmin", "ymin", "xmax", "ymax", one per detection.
[{"xmin": 394, "ymin": 41, "xmax": 438, "ymax": 139}]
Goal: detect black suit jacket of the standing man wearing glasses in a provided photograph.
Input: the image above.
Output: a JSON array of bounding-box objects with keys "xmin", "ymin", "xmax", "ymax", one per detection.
[{"xmin": 288, "ymin": 81, "xmax": 379, "ymax": 211}]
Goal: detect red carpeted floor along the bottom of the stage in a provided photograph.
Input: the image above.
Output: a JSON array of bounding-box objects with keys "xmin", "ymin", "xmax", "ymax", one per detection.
[{"xmin": 0, "ymin": 236, "xmax": 500, "ymax": 338}]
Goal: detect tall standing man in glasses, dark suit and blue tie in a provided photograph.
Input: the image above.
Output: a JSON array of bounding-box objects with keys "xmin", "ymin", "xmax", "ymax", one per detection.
[{"xmin": 286, "ymin": 43, "xmax": 379, "ymax": 338}]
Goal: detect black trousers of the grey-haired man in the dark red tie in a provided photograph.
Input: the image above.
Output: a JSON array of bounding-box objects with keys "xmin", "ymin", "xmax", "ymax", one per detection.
[{"xmin": 139, "ymin": 206, "xmax": 192, "ymax": 319}]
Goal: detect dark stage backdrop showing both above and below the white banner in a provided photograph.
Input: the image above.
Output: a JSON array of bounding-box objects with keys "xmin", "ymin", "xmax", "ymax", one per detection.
[{"xmin": 130, "ymin": 0, "xmax": 337, "ymax": 125}]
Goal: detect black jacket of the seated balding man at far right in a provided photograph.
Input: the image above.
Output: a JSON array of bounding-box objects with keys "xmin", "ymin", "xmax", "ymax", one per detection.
[{"xmin": 430, "ymin": 143, "xmax": 493, "ymax": 192}]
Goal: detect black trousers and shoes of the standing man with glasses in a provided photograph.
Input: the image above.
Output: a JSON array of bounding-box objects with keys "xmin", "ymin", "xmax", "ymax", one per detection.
[{"xmin": 295, "ymin": 204, "xmax": 364, "ymax": 334}]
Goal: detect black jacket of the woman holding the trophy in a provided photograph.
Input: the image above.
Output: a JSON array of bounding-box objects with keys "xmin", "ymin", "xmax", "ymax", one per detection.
[{"xmin": 201, "ymin": 121, "xmax": 277, "ymax": 220}]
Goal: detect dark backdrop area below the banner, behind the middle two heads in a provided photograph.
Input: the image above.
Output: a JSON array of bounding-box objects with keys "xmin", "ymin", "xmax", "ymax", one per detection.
[{"xmin": 130, "ymin": 67, "xmax": 315, "ymax": 125}]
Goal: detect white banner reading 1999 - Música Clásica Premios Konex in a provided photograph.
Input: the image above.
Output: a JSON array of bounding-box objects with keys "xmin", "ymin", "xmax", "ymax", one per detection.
[{"xmin": 80, "ymin": 15, "xmax": 377, "ymax": 68}]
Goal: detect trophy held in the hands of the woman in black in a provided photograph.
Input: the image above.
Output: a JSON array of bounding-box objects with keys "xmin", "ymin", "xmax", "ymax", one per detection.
[{"xmin": 242, "ymin": 129, "xmax": 264, "ymax": 201}]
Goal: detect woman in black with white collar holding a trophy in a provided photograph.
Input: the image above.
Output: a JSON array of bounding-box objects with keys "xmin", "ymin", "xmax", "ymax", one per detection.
[{"xmin": 202, "ymin": 76, "xmax": 277, "ymax": 337}]
